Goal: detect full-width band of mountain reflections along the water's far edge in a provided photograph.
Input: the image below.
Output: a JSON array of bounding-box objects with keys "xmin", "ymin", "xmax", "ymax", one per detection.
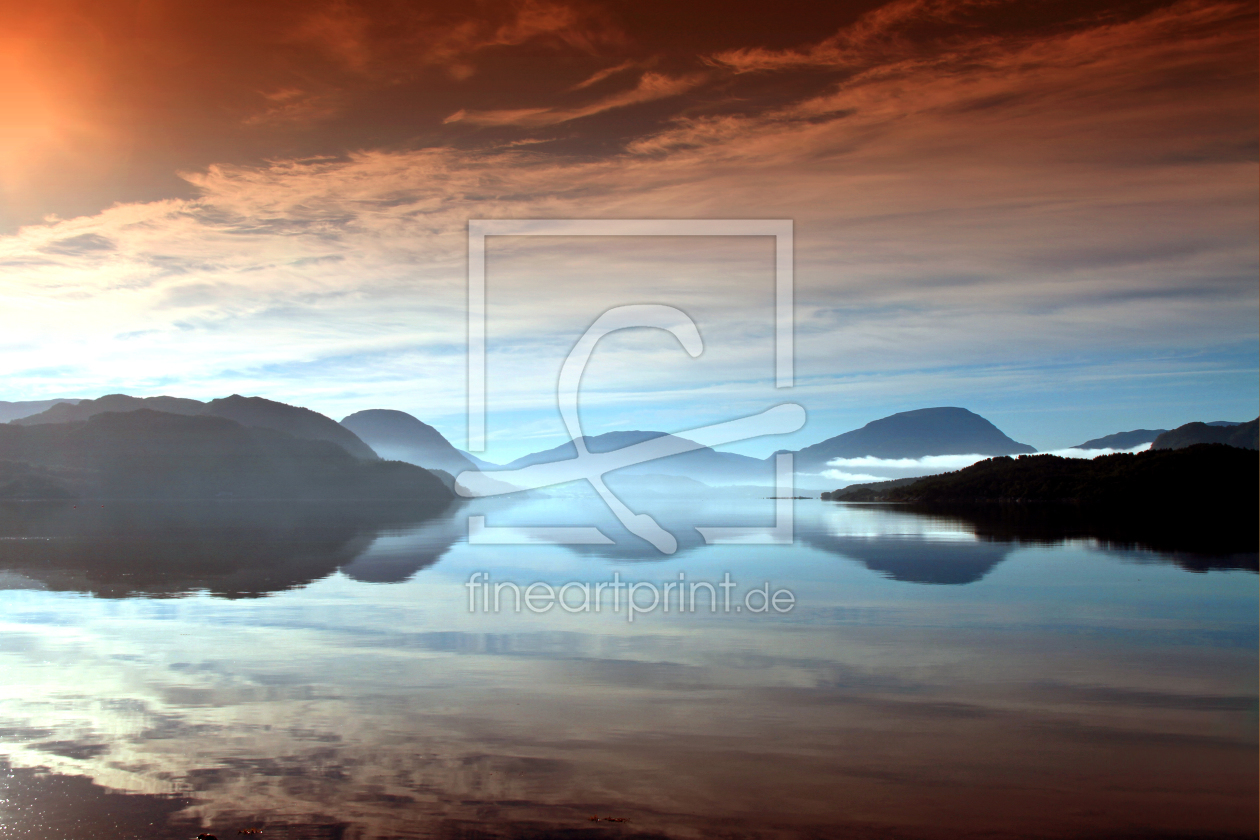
[{"xmin": 0, "ymin": 489, "xmax": 1257, "ymax": 598}]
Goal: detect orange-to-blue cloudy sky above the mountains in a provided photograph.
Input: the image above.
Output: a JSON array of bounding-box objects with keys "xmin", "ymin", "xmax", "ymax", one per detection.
[{"xmin": 0, "ymin": 0, "xmax": 1260, "ymax": 461}]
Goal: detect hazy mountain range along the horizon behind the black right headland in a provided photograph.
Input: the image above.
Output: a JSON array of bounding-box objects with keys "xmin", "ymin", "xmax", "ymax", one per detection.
[{"xmin": 0, "ymin": 394, "xmax": 1256, "ymax": 496}]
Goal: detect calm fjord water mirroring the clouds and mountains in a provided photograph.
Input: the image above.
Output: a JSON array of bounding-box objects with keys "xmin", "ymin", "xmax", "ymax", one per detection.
[{"xmin": 0, "ymin": 494, "xmax": 1260, "ymax": 840}]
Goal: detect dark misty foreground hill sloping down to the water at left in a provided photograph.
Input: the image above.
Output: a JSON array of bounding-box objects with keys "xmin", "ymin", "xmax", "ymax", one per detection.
[{"xmin": 0, "ymin": 409, "xmax": 452, "ymax": 505}]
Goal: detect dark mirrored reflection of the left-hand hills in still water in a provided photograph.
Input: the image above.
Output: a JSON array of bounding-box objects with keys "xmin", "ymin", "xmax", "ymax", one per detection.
[{"xmin": 0, "ymin": 501, "xmax": 460, "ymax": 598}]
